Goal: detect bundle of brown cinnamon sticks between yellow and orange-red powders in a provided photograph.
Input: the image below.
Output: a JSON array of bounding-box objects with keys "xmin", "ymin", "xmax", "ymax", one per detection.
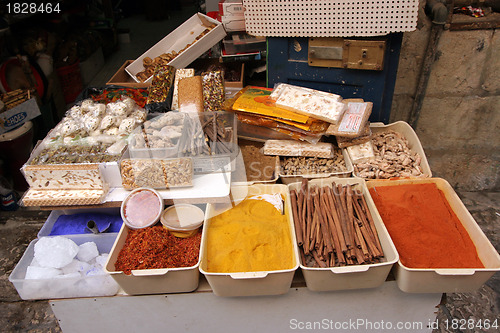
[{"xmin": 290, "ymin": 179, "xmax": 383, "ymax": 267}]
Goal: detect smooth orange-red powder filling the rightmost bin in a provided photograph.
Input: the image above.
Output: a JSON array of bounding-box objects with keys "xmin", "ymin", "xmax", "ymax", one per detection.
[{"xmin": 370, "ymin": 183, "xmax": 484, "ymax": 268}]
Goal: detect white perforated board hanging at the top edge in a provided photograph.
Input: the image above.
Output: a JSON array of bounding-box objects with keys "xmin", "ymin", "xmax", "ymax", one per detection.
[{"xmin": 243, "ymin": 0, "xmax": 419, "ymax": 37}]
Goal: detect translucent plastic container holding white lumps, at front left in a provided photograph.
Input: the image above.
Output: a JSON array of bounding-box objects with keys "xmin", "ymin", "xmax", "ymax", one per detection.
[{"xmin": 9, "ymin": 234, "xmax": 119, "ymax": 300}]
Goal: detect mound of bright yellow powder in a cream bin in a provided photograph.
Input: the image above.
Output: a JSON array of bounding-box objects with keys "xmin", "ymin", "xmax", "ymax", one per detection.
[{"xmin": 206, "ymin": 199, "xmax": 295, "ymax": 273}]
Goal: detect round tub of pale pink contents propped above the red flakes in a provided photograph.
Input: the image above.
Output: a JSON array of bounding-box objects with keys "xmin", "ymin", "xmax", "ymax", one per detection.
[{"xmin": 120, "ymin": 187, "xmax": 163, "ymax": 229}]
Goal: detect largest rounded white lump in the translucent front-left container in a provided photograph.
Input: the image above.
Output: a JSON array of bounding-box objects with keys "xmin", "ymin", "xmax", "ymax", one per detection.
[{"xmin": 34, "ymin": 236, "xmax": 78, "ymax": 268}]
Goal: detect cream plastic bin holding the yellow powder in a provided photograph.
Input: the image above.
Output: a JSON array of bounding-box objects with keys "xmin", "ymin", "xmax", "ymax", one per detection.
[{"xmin": 200, "ymin": 184, "xmax": 299, "ymax": 297}]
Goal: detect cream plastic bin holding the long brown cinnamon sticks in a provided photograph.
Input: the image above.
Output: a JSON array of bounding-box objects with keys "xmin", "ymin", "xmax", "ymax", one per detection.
[{"xmin": 288, "ymin": 177, "xmax": 399, "ymax": 291}]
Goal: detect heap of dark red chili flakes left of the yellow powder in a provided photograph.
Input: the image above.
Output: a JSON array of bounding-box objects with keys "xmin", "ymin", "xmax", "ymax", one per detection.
[{"xmin": 115, "ymin": 225, "xmax": 201, "ymax": 275}]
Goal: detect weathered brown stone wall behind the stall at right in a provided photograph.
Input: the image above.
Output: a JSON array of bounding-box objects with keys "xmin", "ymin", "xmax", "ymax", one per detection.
[{"xmin": 391, "ymin": 6, "xmax": 500, "ymax": 191}]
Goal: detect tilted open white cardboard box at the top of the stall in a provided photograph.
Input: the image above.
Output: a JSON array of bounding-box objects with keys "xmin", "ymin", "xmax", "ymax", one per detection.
[{"xmin": 125, "ymin": 13, "xmax": 226, "ymax": 82}]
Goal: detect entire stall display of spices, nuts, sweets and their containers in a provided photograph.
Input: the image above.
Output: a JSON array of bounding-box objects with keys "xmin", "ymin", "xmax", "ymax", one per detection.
[{"xmin": 9, "ymin": 7, "xmax": 500, "ymax": 330}]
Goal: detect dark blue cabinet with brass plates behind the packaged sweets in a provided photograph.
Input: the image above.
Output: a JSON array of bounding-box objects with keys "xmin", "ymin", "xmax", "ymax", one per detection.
[{"xmin": 267, "ymin": 33, "xmax": 403, "ymax": 123}]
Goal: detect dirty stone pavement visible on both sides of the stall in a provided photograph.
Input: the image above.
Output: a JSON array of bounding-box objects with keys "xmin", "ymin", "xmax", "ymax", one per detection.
[{"xmin": 0, "ymin": 192, "xmax": 500, "ymax": 332}]
